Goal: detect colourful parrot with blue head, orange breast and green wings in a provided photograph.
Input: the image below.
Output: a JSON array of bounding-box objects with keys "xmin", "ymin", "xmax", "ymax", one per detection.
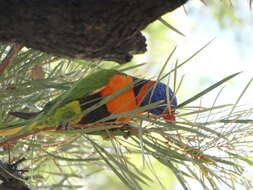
[{"xmin": 6, "ymin": 69, "xmax": 177, "ymax": 133}]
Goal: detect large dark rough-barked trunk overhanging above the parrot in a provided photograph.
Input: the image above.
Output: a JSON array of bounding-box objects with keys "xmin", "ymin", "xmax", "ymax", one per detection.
[{"xmin": 0, "ymin": 0, "xmax": 187, "ymax": 63}]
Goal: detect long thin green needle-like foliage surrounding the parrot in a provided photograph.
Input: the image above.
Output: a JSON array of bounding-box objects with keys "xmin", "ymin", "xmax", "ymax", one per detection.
[{"xmin": 0, "ymin": 44, "xmax": 253, "ymax": 190}]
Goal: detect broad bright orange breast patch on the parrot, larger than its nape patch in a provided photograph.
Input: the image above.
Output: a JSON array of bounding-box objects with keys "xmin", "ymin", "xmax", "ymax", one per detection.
[{"xmin": 100, "ymin": 74, "xmax": 138, "ymax": 120}]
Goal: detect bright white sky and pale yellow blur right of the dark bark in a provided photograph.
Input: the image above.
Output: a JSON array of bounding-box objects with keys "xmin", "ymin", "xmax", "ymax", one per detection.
[{"xmin": 133, "ymin": 0, "xmax": 253, "ymax": 109}]
